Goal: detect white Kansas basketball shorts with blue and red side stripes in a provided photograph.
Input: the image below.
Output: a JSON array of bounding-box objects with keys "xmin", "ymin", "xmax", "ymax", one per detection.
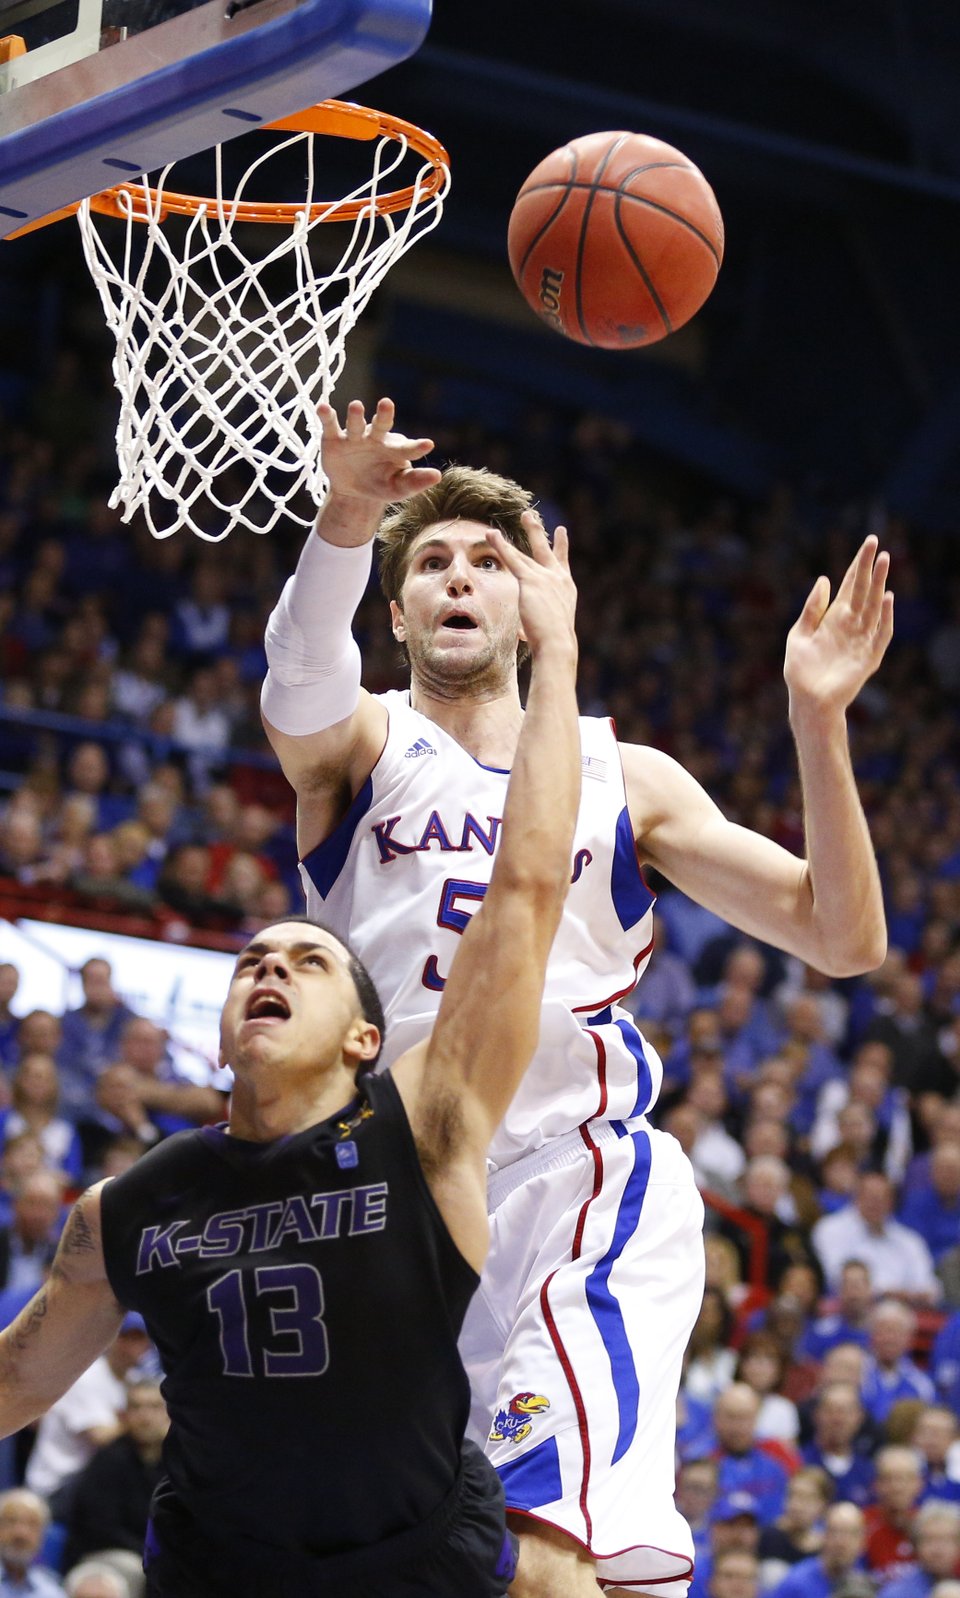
[{"xmin": 487, "ymin": 1130, "xmax": 703, "ymax": 1592}]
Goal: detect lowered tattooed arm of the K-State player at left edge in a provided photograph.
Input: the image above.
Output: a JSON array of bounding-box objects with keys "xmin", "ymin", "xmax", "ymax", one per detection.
[{"xmin": 0, "ymin": 1184, "xmax": 123, "ymax": 1437}]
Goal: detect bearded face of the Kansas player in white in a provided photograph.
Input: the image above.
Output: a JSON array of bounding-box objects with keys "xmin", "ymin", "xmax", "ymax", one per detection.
[{"xmin": 390, "ymin": 521, "xmax": 521, "ymax": 689}]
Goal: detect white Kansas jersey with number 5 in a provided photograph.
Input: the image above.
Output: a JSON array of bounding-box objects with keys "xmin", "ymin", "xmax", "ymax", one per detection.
[{"xmin": 300, "ymin": 692, "xmax": 663, "ymax": 1167}]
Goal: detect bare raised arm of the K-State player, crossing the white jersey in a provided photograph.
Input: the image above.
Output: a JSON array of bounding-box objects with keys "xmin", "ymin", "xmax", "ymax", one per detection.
[{"xmin": 395, "ymin": 511, "xmax": 580, "ymax": 1259}]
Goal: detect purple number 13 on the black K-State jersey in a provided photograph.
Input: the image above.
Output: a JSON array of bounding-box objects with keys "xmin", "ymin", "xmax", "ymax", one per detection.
[{"xmin": 206, "ymin": 1264, "xmax": 331, "ymax": 1376}]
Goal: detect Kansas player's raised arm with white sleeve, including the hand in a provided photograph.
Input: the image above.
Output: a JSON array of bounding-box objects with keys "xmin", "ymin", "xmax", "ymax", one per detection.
[{"xmin": 260, "ymin": 400, "xmax": 439, "ymax": 853}]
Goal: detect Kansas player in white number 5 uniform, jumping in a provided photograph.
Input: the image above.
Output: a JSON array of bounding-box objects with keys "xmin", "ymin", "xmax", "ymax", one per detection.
[{"xmin": 264, "ymin": 401, "xmax": 893, "ymax": 1598}]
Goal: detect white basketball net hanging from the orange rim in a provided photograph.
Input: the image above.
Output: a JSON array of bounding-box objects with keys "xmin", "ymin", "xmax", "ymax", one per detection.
[{"xmin": 78, "ymin": 112, "xmax": 449, "ymax": 542}]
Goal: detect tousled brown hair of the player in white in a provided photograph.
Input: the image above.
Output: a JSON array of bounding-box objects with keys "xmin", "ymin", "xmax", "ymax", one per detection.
[{"xmin": 377, "ymin": 467, "xmax": 534, "ymax": 665}]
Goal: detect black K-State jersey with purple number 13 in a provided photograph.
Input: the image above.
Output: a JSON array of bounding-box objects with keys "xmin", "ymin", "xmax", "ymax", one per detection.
[{"xmin": 102, "ymin": 1072, "xmax": 479, "ymax": 1558}]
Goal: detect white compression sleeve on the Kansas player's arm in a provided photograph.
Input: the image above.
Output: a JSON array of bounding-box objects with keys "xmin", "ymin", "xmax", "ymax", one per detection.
[{"xmin": 260, "ymin": 532, "xmax": 374, "ymax": 738}]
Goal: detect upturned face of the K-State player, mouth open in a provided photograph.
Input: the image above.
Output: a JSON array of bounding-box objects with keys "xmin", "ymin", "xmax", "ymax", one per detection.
[{"xmin": 220, "ymin": 922, "xmax": 379, "ymax": 1074}]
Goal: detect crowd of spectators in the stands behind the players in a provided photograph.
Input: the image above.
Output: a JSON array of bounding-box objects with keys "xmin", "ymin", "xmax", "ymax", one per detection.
[{"xmin": 0, "ymin": 358, "xmax": 960, "ymax": 1598}]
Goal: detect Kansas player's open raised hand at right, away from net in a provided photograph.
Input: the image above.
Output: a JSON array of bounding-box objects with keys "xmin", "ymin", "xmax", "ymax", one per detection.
[{"xmin": 783, "ymin": 534, "xmax": 893, "ymax": 714}]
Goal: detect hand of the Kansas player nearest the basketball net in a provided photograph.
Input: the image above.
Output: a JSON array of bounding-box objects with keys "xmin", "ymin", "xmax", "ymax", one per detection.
[{"xmin": 316, "ymin": 400, "xmax": 441, "ymax": 505}]
